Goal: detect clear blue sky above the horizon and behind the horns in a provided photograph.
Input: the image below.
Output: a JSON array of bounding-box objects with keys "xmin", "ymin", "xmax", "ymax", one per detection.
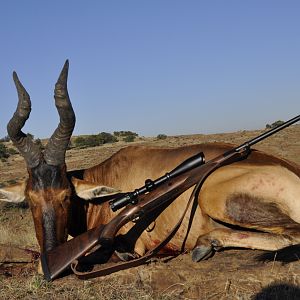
[{"xmin": 0, "ymin": 0, "xmax": 300, "ymax": 138}]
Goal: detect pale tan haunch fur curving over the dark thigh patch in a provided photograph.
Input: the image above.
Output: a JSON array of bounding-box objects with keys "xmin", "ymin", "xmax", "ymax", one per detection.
[{"xmin": 200, "ymin": 164, "xmax": 300, "ymax": 223}]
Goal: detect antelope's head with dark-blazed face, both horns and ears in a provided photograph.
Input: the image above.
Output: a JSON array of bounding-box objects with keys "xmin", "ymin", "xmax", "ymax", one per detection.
[{"xmin": 0, "ymin": 61, "xmax": 119, "ymax": 252}]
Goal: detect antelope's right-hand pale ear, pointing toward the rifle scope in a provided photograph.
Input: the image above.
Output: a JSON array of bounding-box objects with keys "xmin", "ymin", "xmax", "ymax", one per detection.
[{"xmin": 71, "ymin": 177, "xmax": 121, "ymax": 200}]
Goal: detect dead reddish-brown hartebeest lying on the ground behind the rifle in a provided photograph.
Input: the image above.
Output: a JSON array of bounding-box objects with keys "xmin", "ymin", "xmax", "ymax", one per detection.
[{"xmin": 0, "ymin": 62, "xmax": 300, "ymax": 272}]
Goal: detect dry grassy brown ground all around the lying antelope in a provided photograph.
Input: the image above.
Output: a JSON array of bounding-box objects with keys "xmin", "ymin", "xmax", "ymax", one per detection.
[{"xmin": 0, "ymin": 125, "xmax": 300, "ymax": 299}]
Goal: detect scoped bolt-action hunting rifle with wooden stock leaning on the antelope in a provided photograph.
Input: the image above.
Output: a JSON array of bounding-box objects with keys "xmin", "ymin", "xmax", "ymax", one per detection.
[{"xmin": 41, "ymin": 115, "xmax": 300, "ymax": 281}]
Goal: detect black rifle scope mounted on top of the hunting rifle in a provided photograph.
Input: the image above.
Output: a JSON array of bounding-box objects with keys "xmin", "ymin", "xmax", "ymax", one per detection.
[{"xmin": 109, "ymin": 152, "xmax": 205, "ymax": 211}]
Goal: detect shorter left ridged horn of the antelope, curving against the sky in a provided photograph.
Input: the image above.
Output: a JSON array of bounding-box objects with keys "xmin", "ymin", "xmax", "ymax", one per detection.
[{"xmin": 7, "ymin": 72, "xmax": 41, "ymax": 168}]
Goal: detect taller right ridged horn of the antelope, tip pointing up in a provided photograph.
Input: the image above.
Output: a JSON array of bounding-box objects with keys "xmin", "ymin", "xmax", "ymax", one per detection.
[{"xmin": 44, "ymin": 60, "xmax": 75, "ymax": 166}]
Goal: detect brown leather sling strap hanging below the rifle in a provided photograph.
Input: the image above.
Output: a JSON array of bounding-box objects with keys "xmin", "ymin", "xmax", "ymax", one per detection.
[{"xmin": 71, "ymin": 180, "xmax": 204, "ymax": 279}]
